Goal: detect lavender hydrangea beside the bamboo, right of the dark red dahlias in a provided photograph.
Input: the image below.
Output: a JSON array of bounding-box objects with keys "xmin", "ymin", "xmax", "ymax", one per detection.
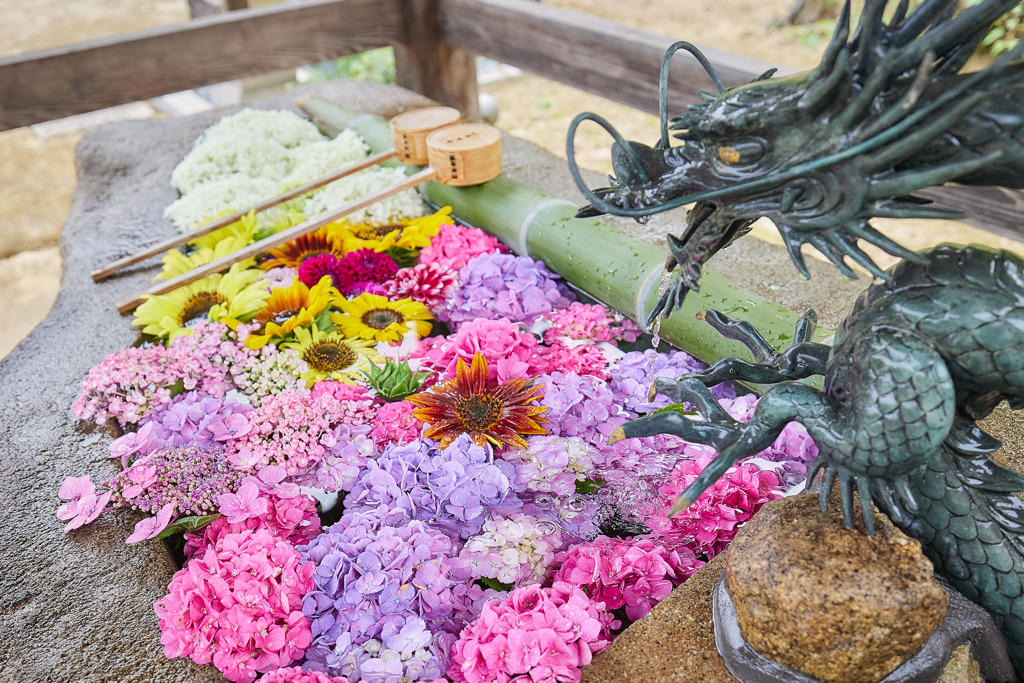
[{"xmin": 438, "ymin": 254, "xmax": 575, "ymax": 326}]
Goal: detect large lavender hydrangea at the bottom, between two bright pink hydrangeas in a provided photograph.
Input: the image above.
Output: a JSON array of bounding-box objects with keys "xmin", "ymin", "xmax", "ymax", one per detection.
[{"xmin": 299, "ymin": 512, "xmax": 459, "ymax": 683}]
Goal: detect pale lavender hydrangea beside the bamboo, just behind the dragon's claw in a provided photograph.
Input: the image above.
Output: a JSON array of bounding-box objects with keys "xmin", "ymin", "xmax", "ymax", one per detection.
[{"xmin": 608, "ymin": 349, "xmax": 736, "ymax": 415}]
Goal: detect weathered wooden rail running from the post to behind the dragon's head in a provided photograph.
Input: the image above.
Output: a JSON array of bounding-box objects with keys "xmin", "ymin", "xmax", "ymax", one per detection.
[{"xmin": 438, "ymin": 0, "xmax": 792, "ymax": 114}]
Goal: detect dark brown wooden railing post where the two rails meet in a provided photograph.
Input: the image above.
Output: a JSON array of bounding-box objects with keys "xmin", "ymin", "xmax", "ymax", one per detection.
[{"xmin": 394, "ymin": 0, "xmax": 480, "ymax": 119}]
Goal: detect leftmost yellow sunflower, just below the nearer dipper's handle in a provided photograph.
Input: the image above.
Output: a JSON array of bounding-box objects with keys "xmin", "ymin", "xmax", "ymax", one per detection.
[{"xmin": 132, "ymin": 263, "xmax": 269, "ymax": 337}]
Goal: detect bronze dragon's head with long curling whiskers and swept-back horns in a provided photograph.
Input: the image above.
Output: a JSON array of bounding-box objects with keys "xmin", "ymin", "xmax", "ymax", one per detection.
[{"xmin": 566, "ymin": 0, "xmax": 1024, "ymax": 324}]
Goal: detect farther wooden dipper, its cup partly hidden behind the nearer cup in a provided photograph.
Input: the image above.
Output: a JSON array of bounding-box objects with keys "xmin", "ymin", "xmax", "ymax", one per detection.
[{"xmin": 92, "ymin": 106, "xmax": 461, "ymax": 283}]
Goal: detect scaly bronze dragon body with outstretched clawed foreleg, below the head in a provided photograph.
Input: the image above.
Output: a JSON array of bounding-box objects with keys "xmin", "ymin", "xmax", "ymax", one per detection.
[{"xmin": 615, "ymin": 246, "xmax": 1024, "ymax": 677}]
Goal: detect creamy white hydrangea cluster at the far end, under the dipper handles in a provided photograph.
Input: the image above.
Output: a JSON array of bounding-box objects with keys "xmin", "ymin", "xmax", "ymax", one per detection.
[{"xmin": 164, "ymin": 110, "xmax": 391, "ymax": 232}]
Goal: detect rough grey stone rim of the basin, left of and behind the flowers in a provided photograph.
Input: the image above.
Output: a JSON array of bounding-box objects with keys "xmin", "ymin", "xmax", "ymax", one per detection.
[{"xmin": 0, "ymin": 78, "xmax": 436, "ymax": 683}]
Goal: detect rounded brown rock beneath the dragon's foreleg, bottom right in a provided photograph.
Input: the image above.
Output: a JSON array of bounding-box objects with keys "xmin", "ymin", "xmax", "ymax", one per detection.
[{"xmin": 726, "ymin": 496, "xmax": 948, "ymax": 683}]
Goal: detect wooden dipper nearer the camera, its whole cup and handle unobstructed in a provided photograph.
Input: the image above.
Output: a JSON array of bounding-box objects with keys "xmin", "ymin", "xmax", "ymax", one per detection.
[{"xmin": 118, "ymin": 123, "xmax": 502, "ymax": 313}]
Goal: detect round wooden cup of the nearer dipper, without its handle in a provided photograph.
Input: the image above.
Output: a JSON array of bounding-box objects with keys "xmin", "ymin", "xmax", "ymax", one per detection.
[{"xmin": 427, "ymin": 123, "xmax": 502, "ymax": 186}]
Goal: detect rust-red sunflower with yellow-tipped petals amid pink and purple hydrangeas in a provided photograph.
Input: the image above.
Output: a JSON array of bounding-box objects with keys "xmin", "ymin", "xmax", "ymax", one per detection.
[{"xmin": 406, "ymin": 353, "xmax": 549, "ymax": 450}]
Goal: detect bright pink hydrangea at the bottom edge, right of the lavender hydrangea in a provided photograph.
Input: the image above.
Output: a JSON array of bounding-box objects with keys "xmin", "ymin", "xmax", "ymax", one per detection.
[{"xmin": 447, "ymin": 582, "xmax": 618, "ymax": 683}]
